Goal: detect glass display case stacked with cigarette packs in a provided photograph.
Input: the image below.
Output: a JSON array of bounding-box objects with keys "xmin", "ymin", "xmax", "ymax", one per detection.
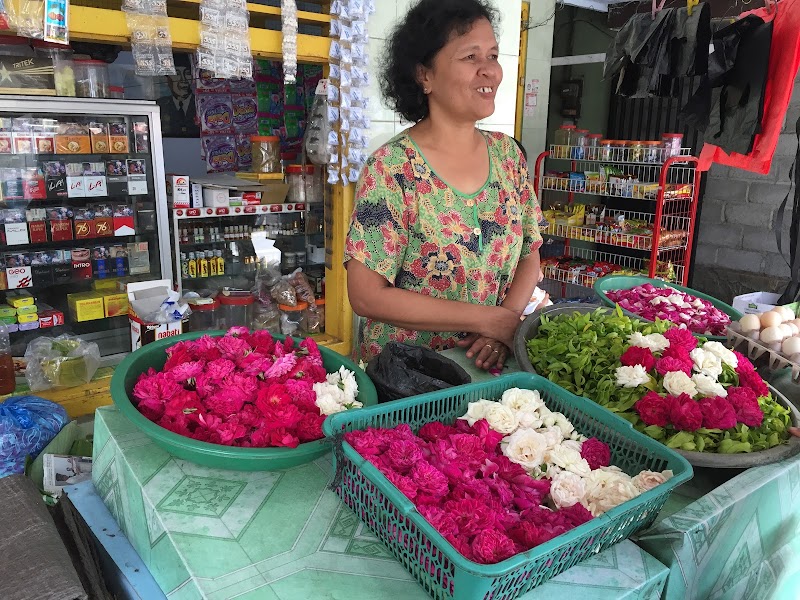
[{"xmin": 0, "ymin": 96, "xmax": 172, "ymax": 356}]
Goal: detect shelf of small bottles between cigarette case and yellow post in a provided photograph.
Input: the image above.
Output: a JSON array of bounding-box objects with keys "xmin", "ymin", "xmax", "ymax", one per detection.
[{"xmin": 173, "ymin": 202, "xmax": 325, "ymax": 293}]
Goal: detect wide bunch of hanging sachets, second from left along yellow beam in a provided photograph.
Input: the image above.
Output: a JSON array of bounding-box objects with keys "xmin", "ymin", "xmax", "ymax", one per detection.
[{"xmin": 197, "ymin": 0, "xmax": 253, "ymax": 79}]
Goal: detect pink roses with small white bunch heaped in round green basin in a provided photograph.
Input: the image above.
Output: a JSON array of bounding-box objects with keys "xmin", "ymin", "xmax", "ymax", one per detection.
[{"xmin": 133, "ymin": 327, "xmax": 361, "ymax": 448}]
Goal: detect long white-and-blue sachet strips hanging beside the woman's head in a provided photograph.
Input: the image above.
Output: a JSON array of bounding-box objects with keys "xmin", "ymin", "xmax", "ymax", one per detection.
[{"xmin": 328, "ymin": 0, "xmax": 375, "ymax": 185}]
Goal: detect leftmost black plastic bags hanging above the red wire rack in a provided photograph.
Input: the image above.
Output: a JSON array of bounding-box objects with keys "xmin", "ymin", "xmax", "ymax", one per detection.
[{"xmin": 603, "ymin": 3, "xmax": 711, "ymax": 97}]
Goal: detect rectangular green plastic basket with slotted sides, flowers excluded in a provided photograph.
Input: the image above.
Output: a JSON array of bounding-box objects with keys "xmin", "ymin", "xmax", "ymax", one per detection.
[{"xmin": 323, "ymin": 373, "xmax": 692, "ymax": 600}]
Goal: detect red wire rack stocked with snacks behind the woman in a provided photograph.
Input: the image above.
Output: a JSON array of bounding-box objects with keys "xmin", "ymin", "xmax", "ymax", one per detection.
[{"xmin": 534, "ymin": 146, "xmax": 700, "ymax": 285}]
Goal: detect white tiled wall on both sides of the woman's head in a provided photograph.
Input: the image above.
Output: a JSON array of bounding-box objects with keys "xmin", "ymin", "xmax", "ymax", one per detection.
[{"xmin": 368, "ymin": 0, "xmax": 522, "ymax": 152}]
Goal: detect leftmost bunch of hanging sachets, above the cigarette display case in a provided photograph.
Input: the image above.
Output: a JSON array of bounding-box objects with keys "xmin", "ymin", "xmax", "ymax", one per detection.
[{"xmin": 122, "ymin": 0, "xmax": 175, "ymax": 77}]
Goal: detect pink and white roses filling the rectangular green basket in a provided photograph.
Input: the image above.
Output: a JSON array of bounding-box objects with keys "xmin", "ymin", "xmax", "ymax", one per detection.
[{"xmin": 345, "ymin": 389, "xmax": 672, "ymax": 564}]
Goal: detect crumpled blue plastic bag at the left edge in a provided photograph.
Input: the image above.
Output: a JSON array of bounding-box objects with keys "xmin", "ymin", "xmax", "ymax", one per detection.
[{"xmin": 0, "ymin": 396, "xmax": 69, "ymax": 477}]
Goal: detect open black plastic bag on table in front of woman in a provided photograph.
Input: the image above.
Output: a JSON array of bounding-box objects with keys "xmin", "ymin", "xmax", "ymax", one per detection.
[{"xmin": 367, "ymin": 342, "xmax": 472, "ymax": 402}]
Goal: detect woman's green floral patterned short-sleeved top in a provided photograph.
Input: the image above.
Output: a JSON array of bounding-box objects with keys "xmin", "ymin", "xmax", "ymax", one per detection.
[{"xmin": 344, "ymin": 132, "xmax": 542, "ymax": 360}]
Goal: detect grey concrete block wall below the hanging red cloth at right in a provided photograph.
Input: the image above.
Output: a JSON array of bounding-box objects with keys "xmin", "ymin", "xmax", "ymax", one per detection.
[{"xmin": 692, "ymin": 77, "xmax": 800, "ymax": 300}]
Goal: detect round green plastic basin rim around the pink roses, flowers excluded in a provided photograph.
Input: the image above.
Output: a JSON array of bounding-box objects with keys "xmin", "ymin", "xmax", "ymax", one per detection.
[{"xmin": 111, "ymin": 331, "xmax": 378, "ymax": 471}]
